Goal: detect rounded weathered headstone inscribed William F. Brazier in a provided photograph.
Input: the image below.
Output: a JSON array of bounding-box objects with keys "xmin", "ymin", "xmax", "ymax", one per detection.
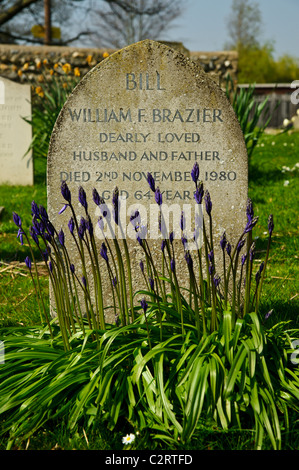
[{"xmin": 48, "ymin": 40, "xmax": 248, "ymax": 322}]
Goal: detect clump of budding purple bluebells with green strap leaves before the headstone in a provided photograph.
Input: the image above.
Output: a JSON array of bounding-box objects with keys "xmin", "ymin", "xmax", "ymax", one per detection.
[{"xmin": 0, "ymin": 164, "xmax": 299, "ymax": 449}]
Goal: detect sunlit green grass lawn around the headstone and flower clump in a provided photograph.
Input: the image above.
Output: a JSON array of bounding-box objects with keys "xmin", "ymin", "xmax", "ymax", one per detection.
[{"xmin": 0, "ymin": 133, "xmax": 299, "ymax": 450}]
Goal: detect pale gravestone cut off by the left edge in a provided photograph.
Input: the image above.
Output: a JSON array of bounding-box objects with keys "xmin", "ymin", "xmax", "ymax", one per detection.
[{"xmin": 0, "ymin": 77, "xmax": 33, "ymax": 185}]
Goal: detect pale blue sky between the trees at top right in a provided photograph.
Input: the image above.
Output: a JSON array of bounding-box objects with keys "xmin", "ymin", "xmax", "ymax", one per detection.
[{"xmin": 161, "ymin": 0, "xmax": 299, "ymax": 59}]
